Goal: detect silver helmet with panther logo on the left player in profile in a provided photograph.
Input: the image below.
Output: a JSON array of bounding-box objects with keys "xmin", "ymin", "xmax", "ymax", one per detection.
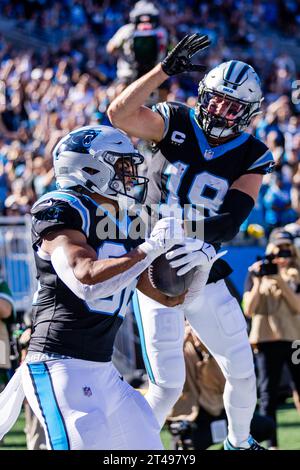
[{"xmin": 53, "ymin": 126, "xmax": 148, "ymax": 203}]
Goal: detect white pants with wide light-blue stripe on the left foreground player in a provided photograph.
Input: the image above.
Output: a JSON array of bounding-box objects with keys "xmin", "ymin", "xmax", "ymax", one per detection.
[{"xmin": 23, "ymin": 359, "xmax": 163, "ymax": 450}]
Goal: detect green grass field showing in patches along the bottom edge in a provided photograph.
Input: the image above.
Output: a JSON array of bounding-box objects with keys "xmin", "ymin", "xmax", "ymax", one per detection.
[{"xmin": 0, "ymin": 400, "xmax": 300, "ymax": 450}]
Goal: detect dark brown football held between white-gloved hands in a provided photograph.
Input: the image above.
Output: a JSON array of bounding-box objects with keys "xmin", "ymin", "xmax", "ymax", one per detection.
[{"xmin": 148, "ymin": 245, "xmax": 196, "ymax": 297}]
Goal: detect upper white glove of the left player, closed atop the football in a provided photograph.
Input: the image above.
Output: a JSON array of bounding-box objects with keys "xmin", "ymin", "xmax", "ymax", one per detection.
[{"xmin": 139, "ymin": 217, "xmax": 184, "ymax": 260}]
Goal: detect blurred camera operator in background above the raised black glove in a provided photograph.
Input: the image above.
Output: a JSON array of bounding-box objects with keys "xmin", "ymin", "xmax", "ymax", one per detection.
[{"xmin": 106, "ymin": 0, "xmax": 168, "ymax": 87}]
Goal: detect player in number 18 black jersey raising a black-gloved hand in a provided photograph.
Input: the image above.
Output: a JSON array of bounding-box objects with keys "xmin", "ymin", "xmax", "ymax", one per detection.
[{"xmin": 108, "ymin": 34, "xmax": 274, "ymax": 450}]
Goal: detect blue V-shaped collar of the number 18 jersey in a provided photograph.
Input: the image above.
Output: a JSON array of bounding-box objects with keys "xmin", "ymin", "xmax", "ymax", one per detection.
[{"xmin": 190, "ymin": 109, "xmax": 250, "ymax": 160}]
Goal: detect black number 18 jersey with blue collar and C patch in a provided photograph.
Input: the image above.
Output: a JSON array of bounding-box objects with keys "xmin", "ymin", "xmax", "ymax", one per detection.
[{"xmin": 148, "ymin": 103, "xmax": 274, "ymax": 216}]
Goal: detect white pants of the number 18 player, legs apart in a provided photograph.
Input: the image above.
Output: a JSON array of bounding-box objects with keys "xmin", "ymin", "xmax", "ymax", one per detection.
[{"xmin": 133, "ymin": 280, "xmax": 256, "ymax": 446}]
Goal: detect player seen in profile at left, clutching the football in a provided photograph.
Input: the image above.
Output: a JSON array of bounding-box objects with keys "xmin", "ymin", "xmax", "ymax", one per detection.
[{"xmin": 0, "ymin": 126, "xmax": 192, "ymax": 450}]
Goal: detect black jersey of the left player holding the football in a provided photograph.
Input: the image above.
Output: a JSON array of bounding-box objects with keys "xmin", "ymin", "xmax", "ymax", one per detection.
[{"xmin": 29, "ymin": 191, "xmax": 139, "ymax": 362}]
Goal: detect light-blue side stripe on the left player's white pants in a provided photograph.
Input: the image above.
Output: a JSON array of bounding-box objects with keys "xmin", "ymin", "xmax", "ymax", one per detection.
[{"xmin": 28, "ymin": 362, "xmax": 70, "ymax": 450}]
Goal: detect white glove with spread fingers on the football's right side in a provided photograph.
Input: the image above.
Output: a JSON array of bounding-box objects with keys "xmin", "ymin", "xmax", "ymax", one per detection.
[{"xmin": 166, "ymin": 238, "xmax": 225, "ymax": 276}]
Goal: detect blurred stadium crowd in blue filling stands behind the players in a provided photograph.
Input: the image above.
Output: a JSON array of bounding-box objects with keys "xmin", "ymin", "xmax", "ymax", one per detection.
[{"xmin": 0, "ymin": 0, "xmax": 300, "ymax": 233}]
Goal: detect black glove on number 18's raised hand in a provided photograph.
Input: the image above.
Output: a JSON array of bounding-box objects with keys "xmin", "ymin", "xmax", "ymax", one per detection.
[{"xmin": 161, "ymin": 34, "xmax": 210, "ymax": 75}]
